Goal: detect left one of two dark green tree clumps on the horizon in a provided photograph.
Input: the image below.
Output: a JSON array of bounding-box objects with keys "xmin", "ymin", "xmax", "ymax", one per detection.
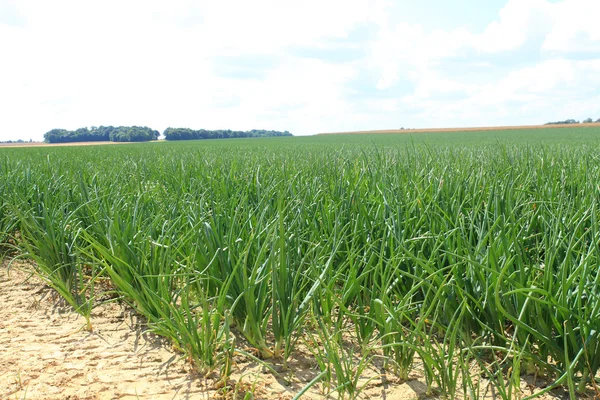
[{"xmin": 44, "ymin": 126, "xmax": 160, "ymax": 143}]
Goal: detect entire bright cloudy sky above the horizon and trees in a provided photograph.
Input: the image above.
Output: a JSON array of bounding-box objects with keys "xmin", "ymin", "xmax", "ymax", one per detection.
[{"xmin": 0, "ymin": 0, "xmax": 600, "ymax": 141}]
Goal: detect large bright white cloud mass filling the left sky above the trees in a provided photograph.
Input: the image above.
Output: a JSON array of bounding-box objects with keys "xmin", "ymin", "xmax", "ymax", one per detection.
[{"xmin": 0, "ymin": 0, "xmax": 382, "ymax": 139}]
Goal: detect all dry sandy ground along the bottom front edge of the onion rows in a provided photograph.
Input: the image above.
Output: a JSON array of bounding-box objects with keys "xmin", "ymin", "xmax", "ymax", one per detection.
[{"xmin": 0, "ymin": 262, "xmax": 580, "ymax": 400}]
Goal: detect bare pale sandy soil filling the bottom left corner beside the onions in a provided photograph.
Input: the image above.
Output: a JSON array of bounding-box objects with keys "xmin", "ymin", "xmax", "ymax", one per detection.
[{"xmin": 0, "ymin": 267, "xmax": 210, "ymax": 400}]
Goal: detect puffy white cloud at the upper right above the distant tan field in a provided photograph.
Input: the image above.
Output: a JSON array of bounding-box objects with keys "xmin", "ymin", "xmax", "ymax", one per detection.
[{"xmin": 360, "ymin": 0, "xmax": 600, "ymax": 126}]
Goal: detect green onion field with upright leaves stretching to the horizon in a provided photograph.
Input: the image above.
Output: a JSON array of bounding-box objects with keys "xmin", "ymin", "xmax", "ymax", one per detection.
[{"xmin": 0, "ymin": 128, "xmax": 600, "ymax": 399}]
